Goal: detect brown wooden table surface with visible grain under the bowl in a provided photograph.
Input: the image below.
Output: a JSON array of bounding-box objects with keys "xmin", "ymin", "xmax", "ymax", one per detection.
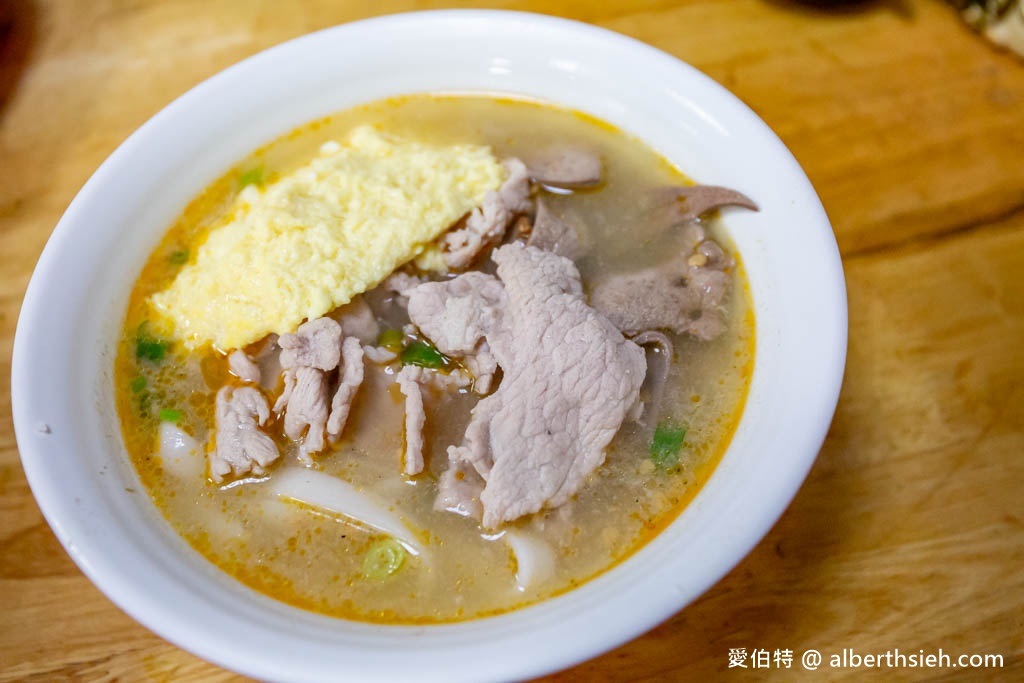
[{"xmin": 0, "ymin": 0, "xmax": 1024, "ymax": 681}]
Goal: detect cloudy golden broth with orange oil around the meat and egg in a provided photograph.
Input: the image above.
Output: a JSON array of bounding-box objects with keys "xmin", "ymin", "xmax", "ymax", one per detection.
[{"xmin": 115, "ymin": 96, "xmax": 754, "ymax": 623}]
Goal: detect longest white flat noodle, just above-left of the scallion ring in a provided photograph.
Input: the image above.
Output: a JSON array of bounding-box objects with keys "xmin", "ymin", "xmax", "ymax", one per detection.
[{"xmin": 266, "ymin": 467, "xmax": 423, "ymax": 555}]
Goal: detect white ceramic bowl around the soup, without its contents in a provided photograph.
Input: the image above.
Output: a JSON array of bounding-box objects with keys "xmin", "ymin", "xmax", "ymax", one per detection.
[{"xmin": 11, "ymin": 11, "xmax": 847, "ymax": 683}]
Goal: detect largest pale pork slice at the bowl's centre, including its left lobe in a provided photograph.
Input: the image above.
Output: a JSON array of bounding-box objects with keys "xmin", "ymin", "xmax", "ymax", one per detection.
[{"xmin": 410, "ymin": 244, "xmax": 646, "ymax": 527}]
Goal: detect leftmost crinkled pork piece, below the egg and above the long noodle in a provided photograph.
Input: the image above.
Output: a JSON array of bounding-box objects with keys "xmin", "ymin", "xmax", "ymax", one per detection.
[{"xmin": 210, "ymin": 386, "xmax": 281, "ymax": 483}]
